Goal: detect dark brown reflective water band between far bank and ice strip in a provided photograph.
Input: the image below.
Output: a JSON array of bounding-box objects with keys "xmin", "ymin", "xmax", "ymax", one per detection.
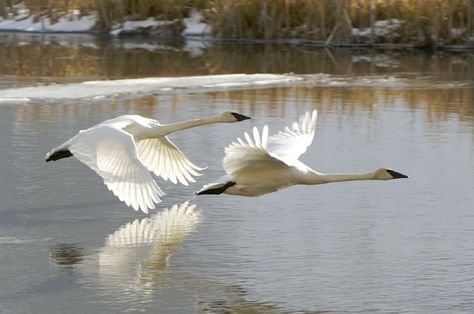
[{"xmin": 0, "ymin": 33, "xmax": 474, "ymax": 84}]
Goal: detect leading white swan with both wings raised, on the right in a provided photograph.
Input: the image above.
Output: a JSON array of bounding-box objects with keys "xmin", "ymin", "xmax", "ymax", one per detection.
[{"xmin": 196, "ymin": 110, "xmax": 408, "ymax": 196}]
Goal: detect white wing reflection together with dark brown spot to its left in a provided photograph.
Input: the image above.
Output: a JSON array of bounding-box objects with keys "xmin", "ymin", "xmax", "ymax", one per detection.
[{"xmin": 50, "ymin": 201, "xmax": 201, "ymax": 297}]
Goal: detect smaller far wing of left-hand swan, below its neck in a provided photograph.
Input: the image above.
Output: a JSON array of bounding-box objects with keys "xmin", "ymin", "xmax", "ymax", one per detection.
[{"xmin": 137, "ymin": 136, "xmax": 203, "ymax": 185}]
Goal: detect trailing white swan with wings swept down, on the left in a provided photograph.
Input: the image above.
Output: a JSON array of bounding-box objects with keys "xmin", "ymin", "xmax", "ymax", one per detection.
[{"xmin": 46, "ymin": 112, "xmax": 250, "ymax": 213}]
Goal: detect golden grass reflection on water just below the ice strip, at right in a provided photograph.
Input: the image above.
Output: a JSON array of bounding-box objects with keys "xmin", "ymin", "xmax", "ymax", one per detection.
[{"xmin": 207, "ymin": 83, "xmax": 474, "ymax": 123}]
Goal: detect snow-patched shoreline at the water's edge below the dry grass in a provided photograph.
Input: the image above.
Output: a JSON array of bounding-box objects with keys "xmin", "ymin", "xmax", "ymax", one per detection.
[{"xmin": 0, "ymin": 10, "xmax": 474, "ymax": 51}]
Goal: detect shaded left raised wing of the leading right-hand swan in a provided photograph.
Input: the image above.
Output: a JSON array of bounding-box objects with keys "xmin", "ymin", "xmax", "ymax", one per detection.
[{"xmin": 223, "ymin": 125, "xmax": 288, "ymax": 181}]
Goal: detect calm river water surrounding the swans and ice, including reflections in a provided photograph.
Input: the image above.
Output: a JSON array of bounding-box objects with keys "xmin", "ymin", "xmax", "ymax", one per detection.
[{"xmin": 0, "ymin": 34, "xmax": 474, "ymax": 314}]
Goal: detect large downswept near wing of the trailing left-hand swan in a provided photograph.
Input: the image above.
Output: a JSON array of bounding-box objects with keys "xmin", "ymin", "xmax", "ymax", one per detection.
[{"xmin": 69, "ymin": 125, "xmax": 164, "ymax": 213}]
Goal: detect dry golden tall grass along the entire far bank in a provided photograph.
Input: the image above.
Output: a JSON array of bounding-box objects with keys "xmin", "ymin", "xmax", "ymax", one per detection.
[{"xmin": 0, "ymin": 0, "xmax": 474, "ymax": 46}]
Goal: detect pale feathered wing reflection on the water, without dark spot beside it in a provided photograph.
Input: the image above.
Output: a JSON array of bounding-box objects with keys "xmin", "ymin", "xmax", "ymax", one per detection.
[{"xmin": 98, "ymin": 202, "xmax": 201, "ymax": 286}]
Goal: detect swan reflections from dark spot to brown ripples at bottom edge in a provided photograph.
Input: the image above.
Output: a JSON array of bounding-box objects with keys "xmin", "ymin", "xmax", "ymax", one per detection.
[{"xmin": 50, "ymin": 202, "xmax": 300, "ymax": 314}]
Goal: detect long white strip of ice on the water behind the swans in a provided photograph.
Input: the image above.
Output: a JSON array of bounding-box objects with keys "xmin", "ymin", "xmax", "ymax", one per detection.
[{"xmin": 0, "ymin": 74, "xmax": 302, "ymax": 103}]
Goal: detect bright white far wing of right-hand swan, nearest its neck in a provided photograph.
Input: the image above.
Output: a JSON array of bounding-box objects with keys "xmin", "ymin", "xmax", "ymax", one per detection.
[{"xmin": 268, "ymin": 110, "xmax": 318, "ymax": 166}]
